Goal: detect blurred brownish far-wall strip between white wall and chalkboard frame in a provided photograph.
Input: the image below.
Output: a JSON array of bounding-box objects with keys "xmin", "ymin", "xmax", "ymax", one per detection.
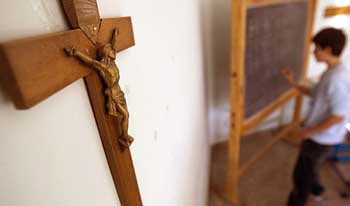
[{"xmin": 201, "ymin": 0, "xmax": 232, "ymax": 143}]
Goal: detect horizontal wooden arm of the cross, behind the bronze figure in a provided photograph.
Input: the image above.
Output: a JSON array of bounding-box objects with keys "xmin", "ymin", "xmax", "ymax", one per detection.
[{"xmin": 0, "ymin": 17, "xmax": 134, "ymax": 109}]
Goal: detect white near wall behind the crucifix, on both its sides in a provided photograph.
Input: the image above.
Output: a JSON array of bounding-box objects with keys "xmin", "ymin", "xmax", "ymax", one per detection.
[{"xmin": 0, "ymin": 0, "xmax": 209, "ymax": 206}]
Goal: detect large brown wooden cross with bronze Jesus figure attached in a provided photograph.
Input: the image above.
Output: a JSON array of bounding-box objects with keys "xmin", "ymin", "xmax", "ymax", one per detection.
[{"xmin": 0, "ymin": 0, "xmax": 142, "ymax": 206}]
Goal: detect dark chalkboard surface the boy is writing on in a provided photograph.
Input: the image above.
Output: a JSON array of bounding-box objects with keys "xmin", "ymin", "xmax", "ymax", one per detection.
[{"xmin": 245, "ymin": 0, "xmax": 308, "ymax": 118}]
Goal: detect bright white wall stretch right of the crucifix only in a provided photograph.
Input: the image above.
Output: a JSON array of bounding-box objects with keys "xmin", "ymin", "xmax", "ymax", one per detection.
[{"xmin": 113, "ymin": 0, "xmax": 209, "ymax": 206}]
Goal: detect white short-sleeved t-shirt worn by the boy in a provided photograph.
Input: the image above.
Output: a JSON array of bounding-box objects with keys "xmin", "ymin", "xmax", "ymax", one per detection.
[{"xmin": 305, "ymin": 63, "xmax": 350, "ymax": 145}]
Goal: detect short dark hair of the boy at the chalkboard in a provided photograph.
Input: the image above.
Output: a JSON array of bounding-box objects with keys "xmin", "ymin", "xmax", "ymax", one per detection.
[{"xmin": 312, "ymin": 28, "xmax": 346, "ymax": 56}]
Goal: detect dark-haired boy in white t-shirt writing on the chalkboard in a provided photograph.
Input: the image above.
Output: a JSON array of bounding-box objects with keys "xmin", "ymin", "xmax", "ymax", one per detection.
[{"xmin": 282, "ymin": 28, "xmax": 350, "ymax": 206}]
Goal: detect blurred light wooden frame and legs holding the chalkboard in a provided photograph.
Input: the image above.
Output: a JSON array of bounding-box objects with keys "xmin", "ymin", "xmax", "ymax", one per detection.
[{"xmin": 223, "ymin": 0, "xmax": 317, "ymax": 204}]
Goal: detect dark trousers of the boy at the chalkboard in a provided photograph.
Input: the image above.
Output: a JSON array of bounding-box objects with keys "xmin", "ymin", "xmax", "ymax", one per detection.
[{"xmin": 288, "ymin": 140, "xmax": 331, "ymax": 206}]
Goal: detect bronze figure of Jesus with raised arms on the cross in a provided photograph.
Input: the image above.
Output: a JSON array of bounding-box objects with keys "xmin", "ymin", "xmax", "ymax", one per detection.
[{"xmin": 65, "ymin": 30, "xmax": 134, "ymax": 147}]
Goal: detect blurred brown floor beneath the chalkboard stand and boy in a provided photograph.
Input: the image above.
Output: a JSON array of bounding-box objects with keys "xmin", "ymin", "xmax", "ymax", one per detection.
[{"xmin": 209, "ymin": 131, "xmax": 350, "ymax": 206}]
